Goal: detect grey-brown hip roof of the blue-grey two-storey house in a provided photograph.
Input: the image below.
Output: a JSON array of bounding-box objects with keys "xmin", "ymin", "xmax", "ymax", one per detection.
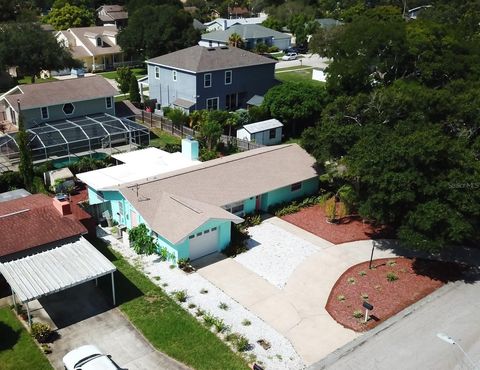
[{"xmin": 147, "ymin": 45, "xmax": 275, "ymax": 72}]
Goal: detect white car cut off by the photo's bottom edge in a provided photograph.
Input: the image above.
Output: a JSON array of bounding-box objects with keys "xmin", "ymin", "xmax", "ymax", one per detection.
[{"xmin": 63, "ymin": 344, "xmax": 118, "ymax": 370}]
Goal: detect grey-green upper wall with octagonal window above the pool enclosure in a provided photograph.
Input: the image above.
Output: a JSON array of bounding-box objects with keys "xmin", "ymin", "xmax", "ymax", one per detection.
[{"xmin": 22, "ymin": 97, "xmax": 115, "ymax": 129}]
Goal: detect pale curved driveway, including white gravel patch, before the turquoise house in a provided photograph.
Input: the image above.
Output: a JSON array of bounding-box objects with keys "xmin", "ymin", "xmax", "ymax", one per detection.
[{"xmin": 198, "ymin": 217, "xmax": 404, "ymax": 364}]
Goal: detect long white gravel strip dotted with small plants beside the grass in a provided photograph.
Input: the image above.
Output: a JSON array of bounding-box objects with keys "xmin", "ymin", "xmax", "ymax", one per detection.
[{"xmin": 102, "ymin": 230, "xmax": 305, "ymax": 370}]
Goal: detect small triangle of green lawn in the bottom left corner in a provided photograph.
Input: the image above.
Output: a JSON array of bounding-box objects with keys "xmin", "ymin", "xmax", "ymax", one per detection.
[{"xmin": 0, "ymin": 307, "xmax": 52, "ymax": 370}]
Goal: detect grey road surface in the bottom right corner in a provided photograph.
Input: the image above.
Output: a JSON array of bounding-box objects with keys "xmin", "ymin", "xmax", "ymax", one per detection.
[{"xmin": 312, "ymin": 281, "xmax": 480, "ymax": 370}]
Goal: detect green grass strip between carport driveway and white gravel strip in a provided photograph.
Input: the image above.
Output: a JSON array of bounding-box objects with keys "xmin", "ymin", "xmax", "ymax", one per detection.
[{"xmin": 92, "ymin": 239, "xmax": 247, "ymax": 370}]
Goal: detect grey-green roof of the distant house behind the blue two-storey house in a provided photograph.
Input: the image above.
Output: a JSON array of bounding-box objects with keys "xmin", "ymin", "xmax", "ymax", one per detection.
[{"xmin": 202, "ymin": 24, "xmax": 290, "ymax": 42}]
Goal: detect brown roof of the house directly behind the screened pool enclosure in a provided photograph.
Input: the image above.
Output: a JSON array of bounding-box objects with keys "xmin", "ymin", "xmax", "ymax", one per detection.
[{"xmin": 5, "ymin": 76, "xmax": 117, "ymax": 109}]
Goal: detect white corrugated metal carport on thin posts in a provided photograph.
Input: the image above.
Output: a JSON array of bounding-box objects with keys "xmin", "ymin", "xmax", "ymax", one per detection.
[{"xmin": 0, "ymin": 237, "xmax": 116, "ymax": 324}]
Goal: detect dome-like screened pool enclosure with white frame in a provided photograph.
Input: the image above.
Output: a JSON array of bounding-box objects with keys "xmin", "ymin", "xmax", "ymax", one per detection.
[{"xmin": 0, "ymin": 114, "xmax": 150, "ymax": 161}]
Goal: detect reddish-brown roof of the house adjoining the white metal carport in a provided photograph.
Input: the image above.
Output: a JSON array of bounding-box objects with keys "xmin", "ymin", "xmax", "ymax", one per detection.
[{"xmin": 0, "ymin": 194, "xmax": 87, "ymax": 256}]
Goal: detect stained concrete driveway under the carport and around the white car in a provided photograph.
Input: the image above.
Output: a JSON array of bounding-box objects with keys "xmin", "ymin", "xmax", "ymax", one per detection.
[{"xmin": 40, "ymin": 283, "xmax": 188, "ymax": 370}]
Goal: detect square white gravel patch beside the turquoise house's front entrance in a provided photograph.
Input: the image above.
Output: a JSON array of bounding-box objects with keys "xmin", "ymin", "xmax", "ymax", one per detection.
[{"xmin": 235, "ymin": 221, "xmax": 320, "ymax": 289}]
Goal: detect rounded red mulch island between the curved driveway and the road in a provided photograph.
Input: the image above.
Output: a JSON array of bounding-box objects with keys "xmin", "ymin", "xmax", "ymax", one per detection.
[{"xmin": 325, "ymin": 258, "xmax": 465, "ymax": 331}]
